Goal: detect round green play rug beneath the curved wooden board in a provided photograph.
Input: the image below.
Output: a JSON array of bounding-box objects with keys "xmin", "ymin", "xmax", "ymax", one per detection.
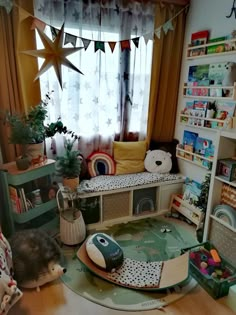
[{"xmin": 61, "ymin": 217, "xmax": 197, "ymax": 311}]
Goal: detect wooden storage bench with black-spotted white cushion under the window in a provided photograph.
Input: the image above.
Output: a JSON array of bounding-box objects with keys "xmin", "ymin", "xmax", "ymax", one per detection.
[{"xmin": 78, "ymin": 172, "xmax": 184, "ymax": 229}]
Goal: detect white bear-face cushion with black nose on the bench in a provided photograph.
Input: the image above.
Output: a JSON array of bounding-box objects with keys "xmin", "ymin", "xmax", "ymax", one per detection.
[{"xmin": 144, "ymin": 150, "xmax": 172, "ymax": 174}]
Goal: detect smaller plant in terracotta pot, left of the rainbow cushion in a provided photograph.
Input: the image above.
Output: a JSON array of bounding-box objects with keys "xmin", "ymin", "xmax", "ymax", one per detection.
[{"xmin": 56, "ymin": 138, "xmax": 82, "ymax": 191}]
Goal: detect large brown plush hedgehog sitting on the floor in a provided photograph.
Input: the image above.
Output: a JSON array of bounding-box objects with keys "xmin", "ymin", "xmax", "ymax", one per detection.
[{"xmin": 9, "ymin": 229, "xmax": 66, "ymax": 291}]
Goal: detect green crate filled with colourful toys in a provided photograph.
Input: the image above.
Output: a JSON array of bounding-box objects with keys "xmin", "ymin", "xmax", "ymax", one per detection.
[{"xmin": 181, "ymin": 242, "xmax": 236, "ymax": 299}]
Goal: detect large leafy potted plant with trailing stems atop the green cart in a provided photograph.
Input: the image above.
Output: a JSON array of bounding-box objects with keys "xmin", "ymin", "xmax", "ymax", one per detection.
[{"xmin": 5, "ymin": 93, "xmax": 78, "ymax": 168}]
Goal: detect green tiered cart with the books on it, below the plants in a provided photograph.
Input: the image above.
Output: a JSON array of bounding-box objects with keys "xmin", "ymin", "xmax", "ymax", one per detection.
[{"xmin": 0, "ymin": 159, "xmax": 58, "ymax": 236}]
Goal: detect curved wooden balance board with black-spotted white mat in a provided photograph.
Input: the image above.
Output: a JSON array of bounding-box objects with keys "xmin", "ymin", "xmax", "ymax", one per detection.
[{"xmin": 77, "ymin": 241, "xmax": 189, "ymax": 291}]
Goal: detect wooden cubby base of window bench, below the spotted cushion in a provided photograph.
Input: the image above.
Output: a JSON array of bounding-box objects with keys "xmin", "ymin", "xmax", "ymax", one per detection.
[{"xmin": 79, "ymin": 178, "xmax": 184, "ymax": 229}]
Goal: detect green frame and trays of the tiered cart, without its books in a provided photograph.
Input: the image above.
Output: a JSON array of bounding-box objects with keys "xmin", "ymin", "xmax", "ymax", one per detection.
[{"xmin": 0, "ymin": 160, "xmax": 58, "ymax": 237}]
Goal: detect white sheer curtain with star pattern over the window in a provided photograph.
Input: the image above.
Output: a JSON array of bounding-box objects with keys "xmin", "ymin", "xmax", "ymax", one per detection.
[{"xmin": 34, "ymin": 0, "xmax": 155, "ymax": 156}]
